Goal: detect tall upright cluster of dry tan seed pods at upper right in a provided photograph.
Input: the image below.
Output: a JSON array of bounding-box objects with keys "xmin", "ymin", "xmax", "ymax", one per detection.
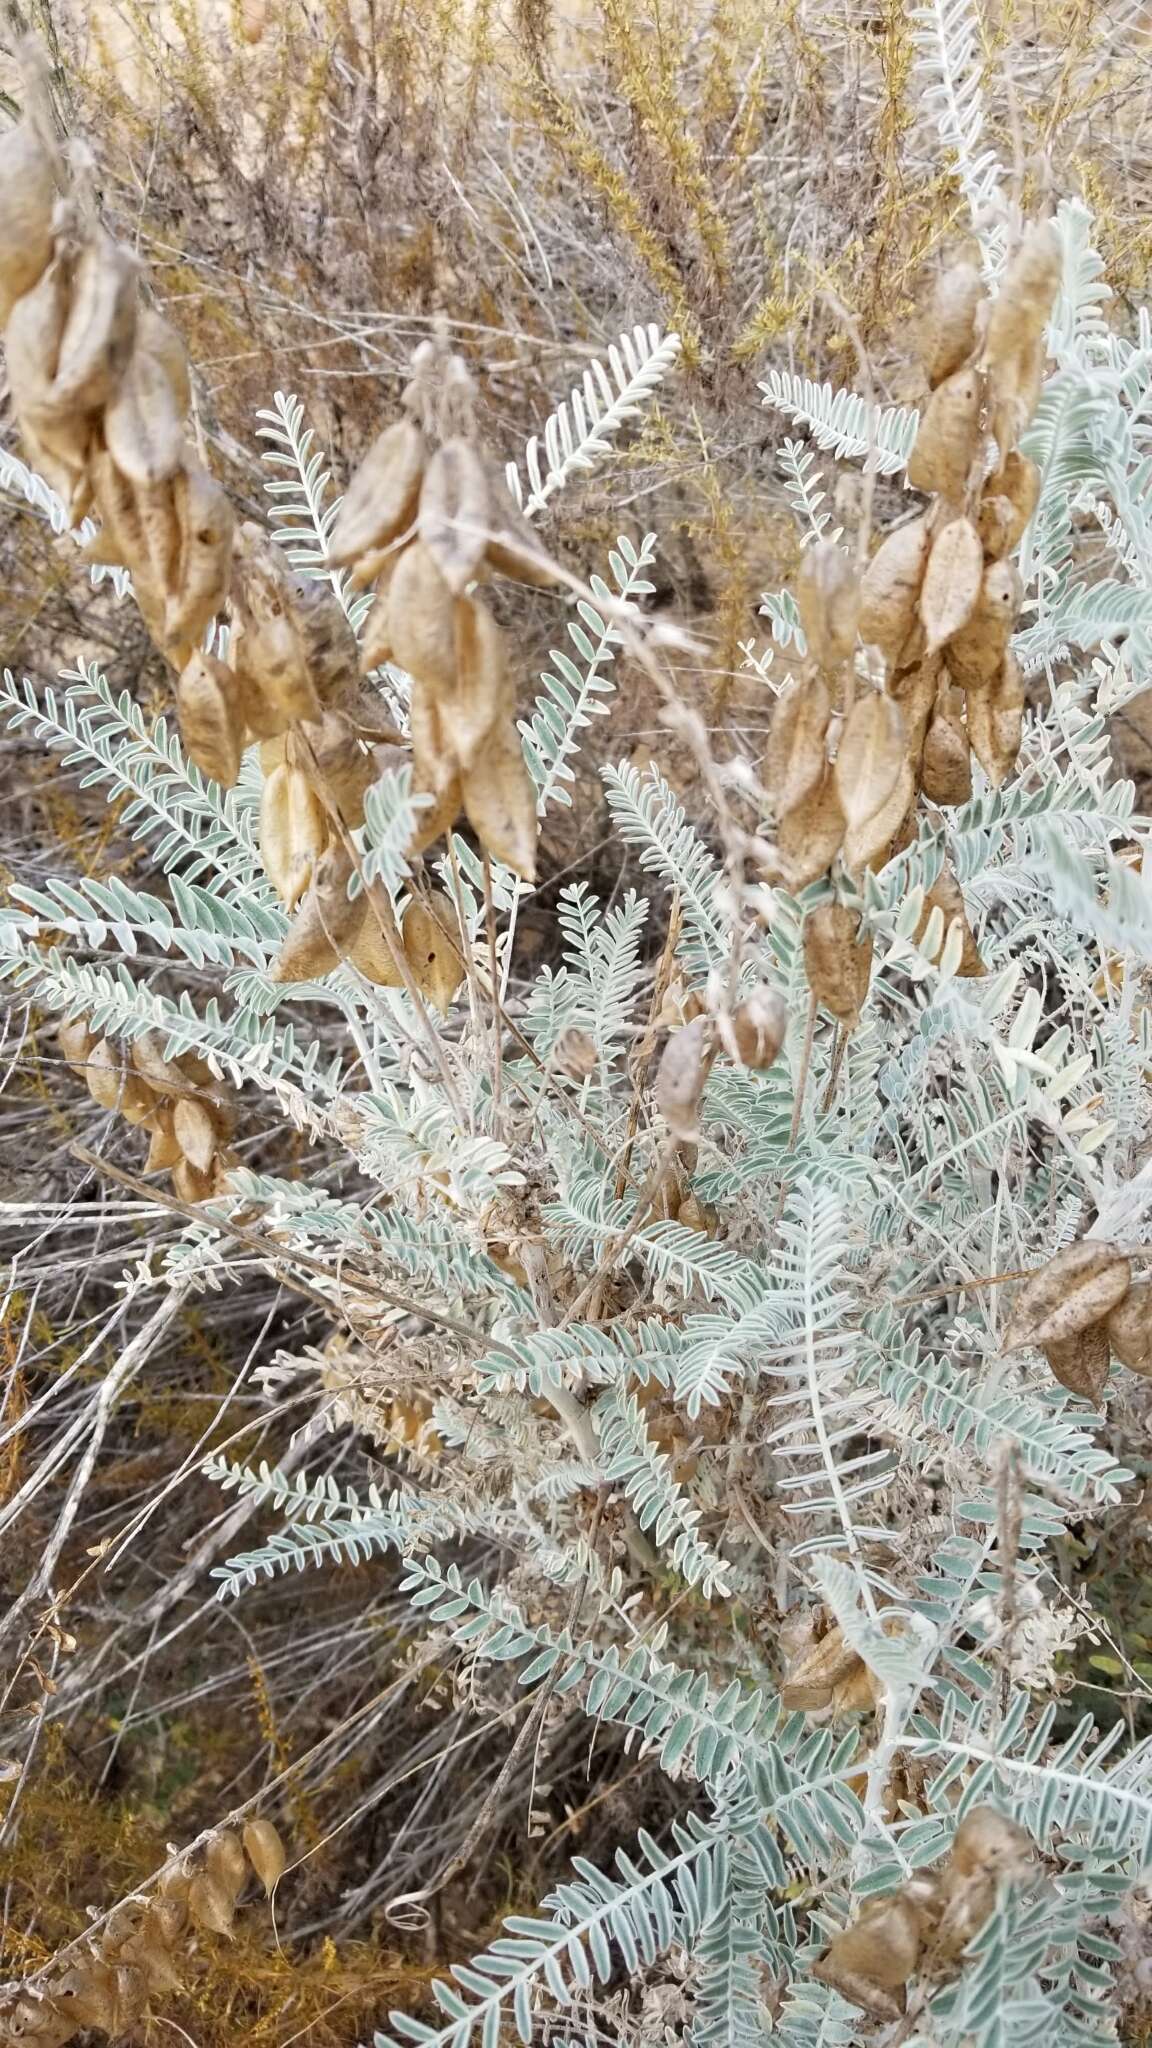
[{"xmin": 763, "ymin": 225, "xmax": 1060, "ymax": 1028}]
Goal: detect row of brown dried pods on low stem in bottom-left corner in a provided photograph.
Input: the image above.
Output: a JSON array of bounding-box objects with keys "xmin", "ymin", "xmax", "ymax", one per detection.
[{"xmin": 0, "ymin": 1821, "xmax": 287, "ymax": 2048}]
